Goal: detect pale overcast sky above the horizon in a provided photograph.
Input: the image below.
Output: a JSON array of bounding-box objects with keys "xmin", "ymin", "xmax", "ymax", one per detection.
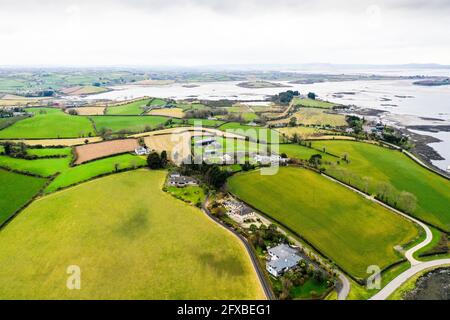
[{"xmin": 0, "ymin": 0, "xmax": 450, "ymax": 66}]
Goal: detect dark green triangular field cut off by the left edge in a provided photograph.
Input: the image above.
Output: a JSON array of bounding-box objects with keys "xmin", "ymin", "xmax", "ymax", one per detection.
[{"xmin": 0, "ymin": 169, "xmax": 47, "ymax": 225}]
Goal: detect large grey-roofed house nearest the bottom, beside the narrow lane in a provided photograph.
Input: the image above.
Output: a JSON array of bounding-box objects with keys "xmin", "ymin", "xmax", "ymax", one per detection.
[{"xmin": 266, "ymin": 243, "xmax": 302, "ymax": 277}]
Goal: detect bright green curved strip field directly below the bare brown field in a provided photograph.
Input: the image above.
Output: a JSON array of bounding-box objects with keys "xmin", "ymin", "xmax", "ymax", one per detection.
[{"xmin": 45, "ymin": 154, "xmax": 146, "ymax": 193}]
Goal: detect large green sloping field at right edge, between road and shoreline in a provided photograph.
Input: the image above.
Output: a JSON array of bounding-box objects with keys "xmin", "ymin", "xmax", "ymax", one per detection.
[{"xmin": 312, "ymin": 141, "xmax": 450, "ymax": 232}]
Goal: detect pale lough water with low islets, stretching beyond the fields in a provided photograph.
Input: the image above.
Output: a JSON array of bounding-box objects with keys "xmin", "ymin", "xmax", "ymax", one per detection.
[{"xmin": 78, "ymin": 76, "xmax": 450, "ymax": 170}]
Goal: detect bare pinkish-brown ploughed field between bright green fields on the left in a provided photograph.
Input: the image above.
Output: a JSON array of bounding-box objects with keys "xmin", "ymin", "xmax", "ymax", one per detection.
[{"xmin": 75, "ymin": 139, "xmax": 139, "ymax": 164}]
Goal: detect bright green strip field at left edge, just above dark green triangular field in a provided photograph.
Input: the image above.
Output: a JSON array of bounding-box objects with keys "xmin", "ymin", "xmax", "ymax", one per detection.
[{"xmin": 0, "ymin": 156, "xmax": 71, "ymax": 177}]
